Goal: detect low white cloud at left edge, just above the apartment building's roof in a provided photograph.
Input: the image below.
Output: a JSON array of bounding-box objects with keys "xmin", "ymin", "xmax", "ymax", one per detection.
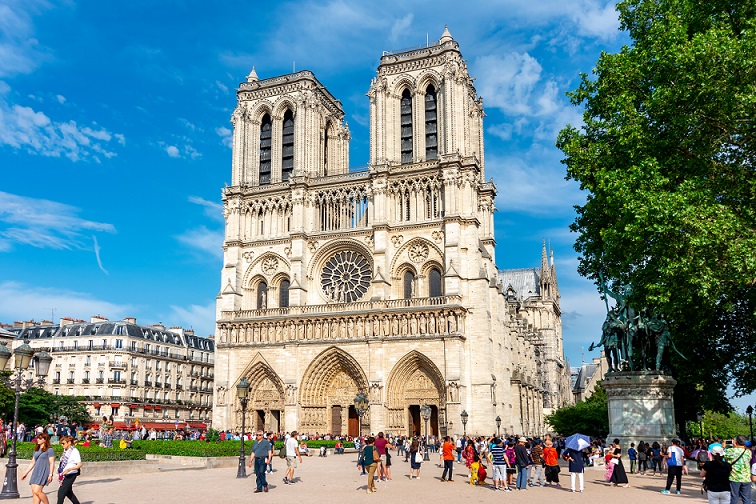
[{"xmin": 0, "ymin": 281, "xmax": 134, "ymax": 322}]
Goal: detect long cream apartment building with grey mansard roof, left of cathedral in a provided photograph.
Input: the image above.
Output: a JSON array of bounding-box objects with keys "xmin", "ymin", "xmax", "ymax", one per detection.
[{"xmin": 8, "ymin": 317, "xmax": 215, "ymax": 428}]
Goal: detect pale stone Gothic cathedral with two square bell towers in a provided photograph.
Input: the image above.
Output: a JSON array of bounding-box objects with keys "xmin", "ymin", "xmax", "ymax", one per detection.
[{"xmin": 213, "ymin": 30, "xmax": 571, "ymax": 435}]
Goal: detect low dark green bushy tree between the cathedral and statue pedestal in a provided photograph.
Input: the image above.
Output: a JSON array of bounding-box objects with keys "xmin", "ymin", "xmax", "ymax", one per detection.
[{"xmin": 546, "ymin": 383, "xmax": 609, "ymax": 438}]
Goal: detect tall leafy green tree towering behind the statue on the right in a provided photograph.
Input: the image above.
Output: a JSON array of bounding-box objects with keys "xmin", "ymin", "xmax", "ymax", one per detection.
[{"xmin": 557, "ymin": 0, "xmax": 756, "ymax": 408}]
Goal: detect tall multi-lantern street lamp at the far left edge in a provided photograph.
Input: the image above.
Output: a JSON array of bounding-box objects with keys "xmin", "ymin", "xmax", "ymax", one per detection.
[{"xmin": 0, "ymin": 340, "xmax": 52, "ymax": 499}]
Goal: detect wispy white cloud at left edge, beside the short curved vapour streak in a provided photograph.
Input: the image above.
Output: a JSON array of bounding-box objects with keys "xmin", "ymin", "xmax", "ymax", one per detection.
[{"xmin": 0, "ymin": 192, "xmax": 116, "ymax": 251}]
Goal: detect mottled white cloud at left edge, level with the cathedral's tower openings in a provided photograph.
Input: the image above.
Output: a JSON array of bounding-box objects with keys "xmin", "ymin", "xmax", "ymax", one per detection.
[{"xmin": 0, "ymin": 83, "xmax": 124, "ymax": 162}]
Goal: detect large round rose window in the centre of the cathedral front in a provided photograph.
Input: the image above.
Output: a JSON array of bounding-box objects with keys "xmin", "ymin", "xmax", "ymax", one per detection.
[{"xmin": 320, "ymin": 250, "xmax": 372, "ymax": 303}]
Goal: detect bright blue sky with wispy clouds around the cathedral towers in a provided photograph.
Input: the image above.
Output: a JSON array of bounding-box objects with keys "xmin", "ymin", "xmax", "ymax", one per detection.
[{"xmin": 0, "ymin": 0, "xmax": 748, "ymax": 410}]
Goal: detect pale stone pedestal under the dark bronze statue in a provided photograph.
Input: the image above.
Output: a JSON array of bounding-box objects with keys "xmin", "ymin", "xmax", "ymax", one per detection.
[{"xmin": 602, "ymin": 371, "xmax": 677, "ymax": 444}]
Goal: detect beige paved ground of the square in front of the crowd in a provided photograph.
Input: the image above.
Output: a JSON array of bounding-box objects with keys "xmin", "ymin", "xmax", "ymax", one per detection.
[{"xmin": 14, "ymin": 454, "xmax": 705, "ymax": 504}]
